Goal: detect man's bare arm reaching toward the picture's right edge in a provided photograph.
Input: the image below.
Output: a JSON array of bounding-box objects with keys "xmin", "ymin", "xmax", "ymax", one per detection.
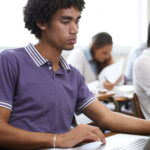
[{"xmin": 83, "ymin": 100, "xmax": 150, "ymax": 134}]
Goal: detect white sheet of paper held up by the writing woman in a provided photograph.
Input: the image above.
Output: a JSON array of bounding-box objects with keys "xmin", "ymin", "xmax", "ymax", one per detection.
[{"xmin": 100, "ymin": 58, "xmax": 124, "ymax": 83}]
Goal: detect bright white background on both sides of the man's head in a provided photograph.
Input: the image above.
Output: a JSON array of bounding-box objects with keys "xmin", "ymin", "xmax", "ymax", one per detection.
[{"xmin": 0, "ymin": 0, "xmax": 150, "ymax": 52}]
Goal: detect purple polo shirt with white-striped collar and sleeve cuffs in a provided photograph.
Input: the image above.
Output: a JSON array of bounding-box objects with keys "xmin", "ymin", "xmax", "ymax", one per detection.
[{"xmin": 0, "ymin": 44, "xmax": 96, "ymax": 133}]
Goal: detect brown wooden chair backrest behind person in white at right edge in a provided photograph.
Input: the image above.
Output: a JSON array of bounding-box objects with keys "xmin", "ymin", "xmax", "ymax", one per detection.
[{"xmin": 133, "ymin": 93, "xmax": 145, "ymax": 119}]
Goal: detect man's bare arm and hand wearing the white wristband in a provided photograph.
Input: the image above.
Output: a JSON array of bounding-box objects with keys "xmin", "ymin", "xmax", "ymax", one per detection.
[{"xmin": 0, "ymin": 107, "xmax": 105, "ymax": 150}]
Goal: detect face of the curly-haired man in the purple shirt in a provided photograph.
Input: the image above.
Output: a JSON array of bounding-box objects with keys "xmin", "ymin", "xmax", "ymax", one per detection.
[{"xmin": 42, "ymin": 7, "xmax": 80, "ymax": 50}]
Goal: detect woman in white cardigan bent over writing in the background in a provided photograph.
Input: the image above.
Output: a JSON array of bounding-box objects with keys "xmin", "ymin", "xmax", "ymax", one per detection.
[{"xmin": 67, "ymin": 32, "xmax": 121, "ymax": 90}]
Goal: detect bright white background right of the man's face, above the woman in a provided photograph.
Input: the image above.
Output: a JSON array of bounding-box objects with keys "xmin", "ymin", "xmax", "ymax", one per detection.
[{"xmin": 78, "ymin": 0, "xmax": 147, "ymax": 46}]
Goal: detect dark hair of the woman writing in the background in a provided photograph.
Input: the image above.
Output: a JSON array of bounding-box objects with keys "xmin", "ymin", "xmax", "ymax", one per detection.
[{"xmin": 90, "ymin": 32, "xmax": 113, "ymax": 74}]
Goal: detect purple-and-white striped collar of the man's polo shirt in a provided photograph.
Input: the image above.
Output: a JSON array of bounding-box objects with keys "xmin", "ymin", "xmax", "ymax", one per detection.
[{"xmin": 25, "ymin": 43, "xmax": 71, "ymax": 71}]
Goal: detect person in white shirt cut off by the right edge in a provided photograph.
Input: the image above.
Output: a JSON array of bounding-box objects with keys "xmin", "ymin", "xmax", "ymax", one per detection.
[{"xmin": 133, "ymin": 24, "xmax": 150, "ymax": 120}]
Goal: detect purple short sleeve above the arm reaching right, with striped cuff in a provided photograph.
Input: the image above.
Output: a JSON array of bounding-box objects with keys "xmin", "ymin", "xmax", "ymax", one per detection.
[{"xmin": 75, "ymin": 69, "xmax": 96, "ymax": 114}]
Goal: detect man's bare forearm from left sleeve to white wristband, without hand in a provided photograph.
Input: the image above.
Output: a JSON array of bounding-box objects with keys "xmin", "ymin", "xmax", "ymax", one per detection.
[{"xmin": 0, "ymin": 107, "xmax": 53, "ymax": 149}]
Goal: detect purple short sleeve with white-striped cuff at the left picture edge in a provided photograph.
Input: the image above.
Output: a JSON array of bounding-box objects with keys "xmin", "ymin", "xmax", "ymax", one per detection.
[{"xmin": 0, "ymin": 52, "xmax": 16, "ymax": 110}]
